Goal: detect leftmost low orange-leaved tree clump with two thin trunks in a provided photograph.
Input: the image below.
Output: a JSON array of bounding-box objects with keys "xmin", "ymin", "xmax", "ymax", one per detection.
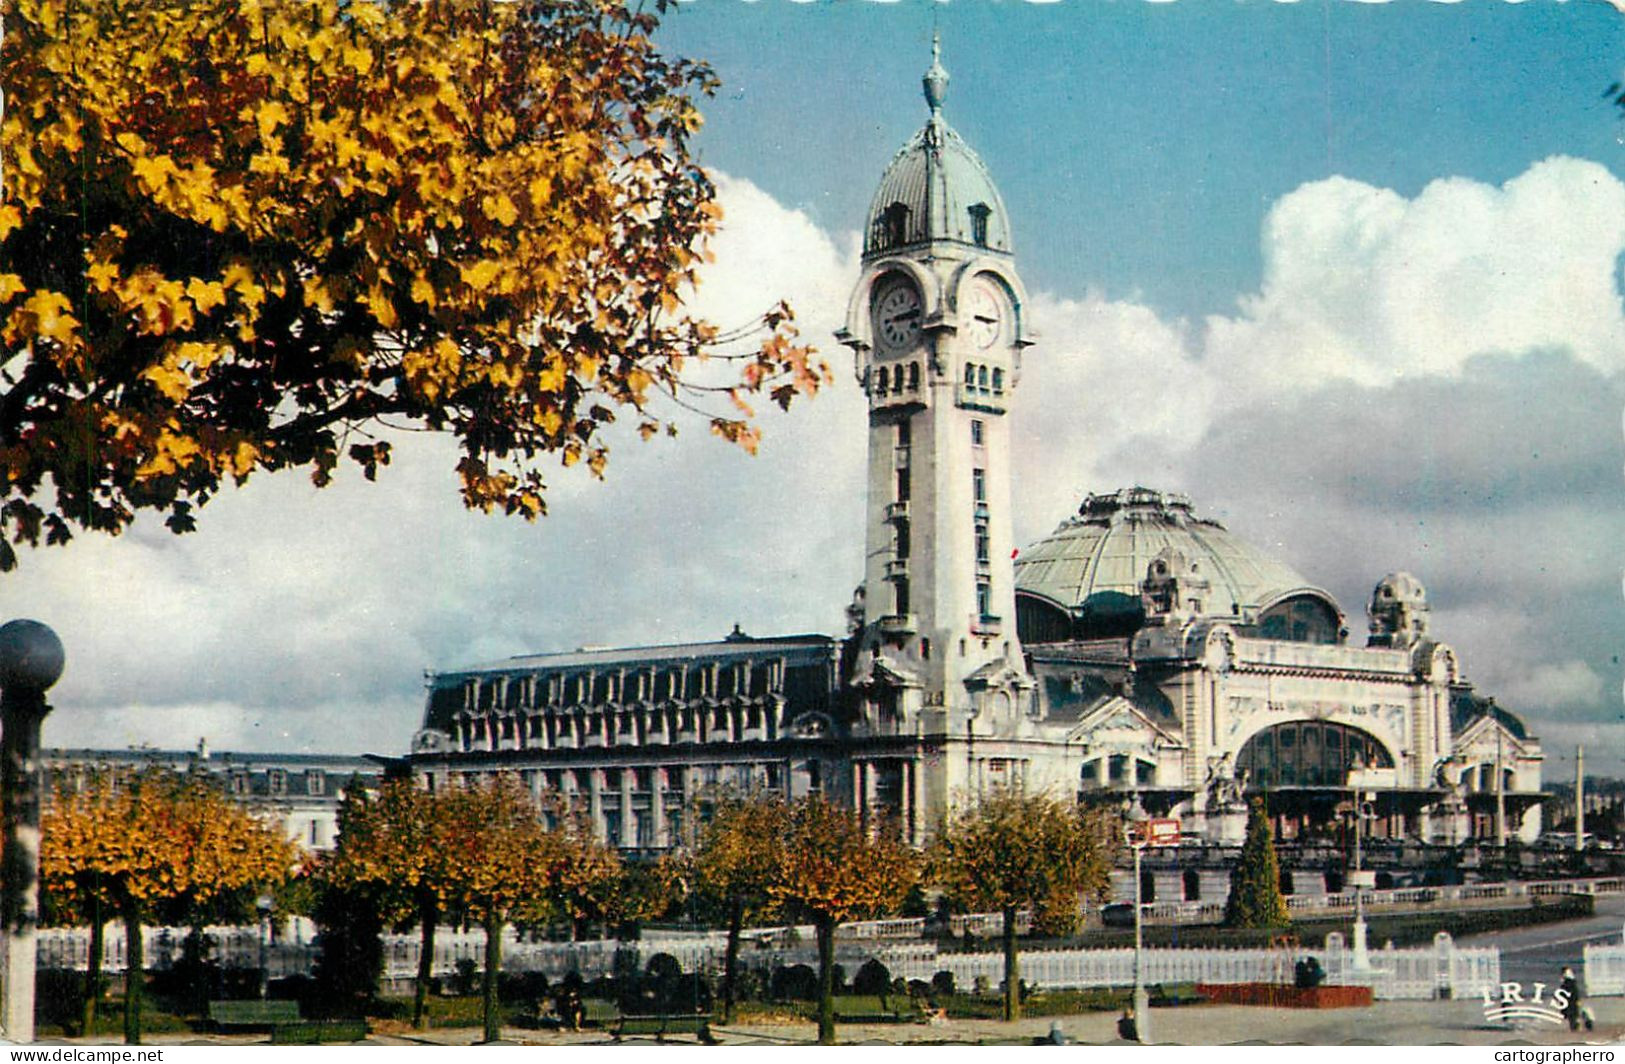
[{"xmin": 39, "ymin": 770, "xmax": 296, "ymax": 1045}]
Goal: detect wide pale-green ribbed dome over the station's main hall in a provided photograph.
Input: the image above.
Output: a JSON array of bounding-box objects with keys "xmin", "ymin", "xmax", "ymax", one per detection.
[{"xmin": 1016, "ymin": 487, "xmax": 1342, "ymax": 642}]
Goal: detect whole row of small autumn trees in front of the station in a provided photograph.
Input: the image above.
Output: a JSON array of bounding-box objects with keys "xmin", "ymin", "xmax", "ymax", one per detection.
[{"xmin": 41, "ymin": 772, "xmax": 1116, "ymax": 1045}]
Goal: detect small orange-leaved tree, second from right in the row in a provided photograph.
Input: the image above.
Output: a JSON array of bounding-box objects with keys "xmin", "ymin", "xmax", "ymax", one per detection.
[{"xmin": 769, "ymin": 794, "xmax": 920, "ymax": 1045}]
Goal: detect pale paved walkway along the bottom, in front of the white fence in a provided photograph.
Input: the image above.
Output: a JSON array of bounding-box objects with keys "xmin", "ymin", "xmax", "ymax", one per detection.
[{"xmin": 59, "ymin": 997, "xmax": 1625, "ymax": 1046}]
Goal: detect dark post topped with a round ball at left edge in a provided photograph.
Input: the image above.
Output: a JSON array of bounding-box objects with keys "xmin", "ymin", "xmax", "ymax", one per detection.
[{"xmin": 0, "ymin": 621, "xmax": 65, "ymax": 1043}]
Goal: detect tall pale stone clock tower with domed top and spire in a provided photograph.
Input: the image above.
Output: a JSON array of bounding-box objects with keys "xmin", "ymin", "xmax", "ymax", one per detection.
[{"xmin": 837, "ymin": 45, "xmax": 1032, "ymax": 838}]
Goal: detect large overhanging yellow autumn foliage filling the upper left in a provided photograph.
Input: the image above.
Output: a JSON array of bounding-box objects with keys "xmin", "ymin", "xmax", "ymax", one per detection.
[{"xmin": 0, "ymin": 0, "xmax": 829, "ymax": 569}]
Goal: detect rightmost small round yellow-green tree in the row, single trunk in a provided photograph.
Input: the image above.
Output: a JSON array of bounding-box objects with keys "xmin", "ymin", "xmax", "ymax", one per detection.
[{"xmin": 926, "ymin": 789, "xmax": 1116, "ymax": 1020}]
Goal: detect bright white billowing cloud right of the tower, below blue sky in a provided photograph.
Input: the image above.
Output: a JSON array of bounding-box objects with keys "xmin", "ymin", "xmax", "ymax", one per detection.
[{"xmin": 1203, "ymin": 158, "xmax": 1625, "ymax": 391}]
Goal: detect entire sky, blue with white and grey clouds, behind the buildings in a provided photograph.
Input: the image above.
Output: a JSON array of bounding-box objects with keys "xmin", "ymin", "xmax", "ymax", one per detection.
[{"xmin": 12, "ymin": 0, "xmax": 1625, "ymax": 778}]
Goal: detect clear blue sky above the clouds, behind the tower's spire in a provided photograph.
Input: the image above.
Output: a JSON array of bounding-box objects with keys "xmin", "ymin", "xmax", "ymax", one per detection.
[{"xmin": 665, "ymin": 0, "xmax": 1625, "ymax": 314}]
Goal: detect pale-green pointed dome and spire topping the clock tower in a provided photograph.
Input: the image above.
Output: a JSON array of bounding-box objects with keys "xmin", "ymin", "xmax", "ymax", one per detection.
[{"xmin": 863, "ymin": 44, "xmax": 1011, "ymax": 255}]
